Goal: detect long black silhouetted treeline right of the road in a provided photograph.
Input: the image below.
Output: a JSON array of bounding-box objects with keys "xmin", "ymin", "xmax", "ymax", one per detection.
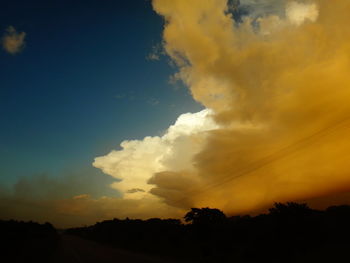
[{"xmin": 67, "ymin": 203, "xmax": 350, "ymax": 263}]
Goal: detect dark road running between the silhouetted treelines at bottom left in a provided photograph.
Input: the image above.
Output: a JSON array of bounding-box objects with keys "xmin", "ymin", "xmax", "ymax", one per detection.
[{"xmin": 52, "ymin": 234, "xmax": 180, "ymax": 263}]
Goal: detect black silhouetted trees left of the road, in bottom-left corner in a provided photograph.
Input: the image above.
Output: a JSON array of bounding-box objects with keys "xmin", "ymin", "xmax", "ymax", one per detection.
[{"xmin": 0, "ymin": 220, "xmax": 59, "ymax": 262}]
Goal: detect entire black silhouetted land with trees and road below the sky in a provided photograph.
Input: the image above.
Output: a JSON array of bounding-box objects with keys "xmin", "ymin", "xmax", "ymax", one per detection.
[{"xmin": 0, "ymin": 203, "xmax": 350, "ymax": 263}]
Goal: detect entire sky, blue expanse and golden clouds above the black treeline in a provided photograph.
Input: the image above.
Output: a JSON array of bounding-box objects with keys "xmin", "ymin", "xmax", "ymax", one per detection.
[{"xmin": 0, "ymin": 0, "xmax": 350, "ymax": 227}]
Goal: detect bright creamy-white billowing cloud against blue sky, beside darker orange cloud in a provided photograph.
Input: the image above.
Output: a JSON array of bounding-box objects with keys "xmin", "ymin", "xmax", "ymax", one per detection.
[{"xmin": 93, "ymin": 109, "xmax": 218, "ymax": 199}]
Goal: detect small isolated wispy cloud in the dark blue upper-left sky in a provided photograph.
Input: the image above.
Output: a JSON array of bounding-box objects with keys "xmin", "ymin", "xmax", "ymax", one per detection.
[{"xmin": 2, "ymin": 26, "xmax": 26, "ymax": 55}]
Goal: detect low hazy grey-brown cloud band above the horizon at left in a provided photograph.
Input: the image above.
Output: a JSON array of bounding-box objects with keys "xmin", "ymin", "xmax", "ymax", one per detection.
[{"xmin": 0, "ymin": 172, "xmax": 184, "ymax": 228}]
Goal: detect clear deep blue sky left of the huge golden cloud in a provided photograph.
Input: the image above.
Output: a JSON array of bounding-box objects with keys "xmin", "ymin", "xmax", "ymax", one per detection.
[{"xmin": 0, "ymin": 0, "xmax": 201, "ymax": 194}]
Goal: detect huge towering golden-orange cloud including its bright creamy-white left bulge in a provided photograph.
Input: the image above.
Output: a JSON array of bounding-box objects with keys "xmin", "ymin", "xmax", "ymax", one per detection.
[{"xmin": 94, "ymin": 0, "xmax": 350, "ymax": 219}]
